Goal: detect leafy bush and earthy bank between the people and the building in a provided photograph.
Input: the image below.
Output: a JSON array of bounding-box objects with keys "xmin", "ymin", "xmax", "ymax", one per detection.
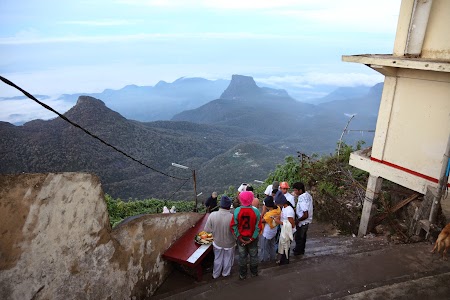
[{"xmin": 266, "ymin": 142, "xmax": 368, "ymax": 233}]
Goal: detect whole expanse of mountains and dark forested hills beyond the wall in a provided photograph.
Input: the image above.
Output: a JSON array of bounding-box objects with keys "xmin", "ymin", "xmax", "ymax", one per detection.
[{"xmin": 0, "ymin": 75, "xmax": 382, "ymax": 199}]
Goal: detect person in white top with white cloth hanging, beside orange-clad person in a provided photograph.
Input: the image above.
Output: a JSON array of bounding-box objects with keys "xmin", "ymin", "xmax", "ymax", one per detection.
[{"xmin": 274, "ymin": 191, "xmax": 296, "ymax": 265}]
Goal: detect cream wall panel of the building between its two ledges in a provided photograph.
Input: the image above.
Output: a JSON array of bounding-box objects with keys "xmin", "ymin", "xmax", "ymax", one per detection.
[{"xmin": 372, "ymin": 69, "xmax": 450, "ymax": 180}]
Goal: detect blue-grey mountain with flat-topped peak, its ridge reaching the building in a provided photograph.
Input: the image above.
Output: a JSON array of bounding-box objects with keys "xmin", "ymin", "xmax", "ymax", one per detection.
[{"xmin": 172, "ymin": 75, "xmax": 382, "ymax": 154}]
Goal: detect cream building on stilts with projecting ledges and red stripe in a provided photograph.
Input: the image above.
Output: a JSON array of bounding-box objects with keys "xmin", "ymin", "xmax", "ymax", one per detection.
[{"xmin": 342, "ymin": 0, "xmax": 450, "ymax": 236}]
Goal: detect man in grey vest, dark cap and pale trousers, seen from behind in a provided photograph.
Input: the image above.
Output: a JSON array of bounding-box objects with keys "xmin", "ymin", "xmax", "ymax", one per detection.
[{"xmin": 204, "ymin": 195, "xmax": 236, "ymax": 279}]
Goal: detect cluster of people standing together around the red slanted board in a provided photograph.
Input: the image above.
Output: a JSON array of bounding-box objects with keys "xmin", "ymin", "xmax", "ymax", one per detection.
[{"xmin": 204, "ymin": 181, "xmax": 313, "ymax": 279}]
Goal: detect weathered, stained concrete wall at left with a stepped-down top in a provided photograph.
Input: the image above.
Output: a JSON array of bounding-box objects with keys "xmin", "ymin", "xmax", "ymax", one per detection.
[{"xmin": 0, "ymin": 173, "xmax": 201, "ymax": 300}]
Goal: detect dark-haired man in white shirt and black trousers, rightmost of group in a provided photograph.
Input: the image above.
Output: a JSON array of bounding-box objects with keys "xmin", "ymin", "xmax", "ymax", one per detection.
[{"xmin": 292, "ymin": 182, "xmax": 313, "ymax": 255}]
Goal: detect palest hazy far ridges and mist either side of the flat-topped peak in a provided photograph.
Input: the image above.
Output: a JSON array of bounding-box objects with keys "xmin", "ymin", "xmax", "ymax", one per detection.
[{"xmin": 0, "ymin": 77, "xmax": 380, "ymax": 125}]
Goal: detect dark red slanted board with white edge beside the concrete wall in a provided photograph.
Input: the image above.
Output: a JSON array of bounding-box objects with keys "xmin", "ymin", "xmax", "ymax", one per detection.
[{"xmin": 162, "ymin": 213, "xmax": 212, "ymax": 281}]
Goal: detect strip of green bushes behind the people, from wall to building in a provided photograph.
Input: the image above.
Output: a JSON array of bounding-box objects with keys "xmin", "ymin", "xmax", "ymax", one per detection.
[{"xmin": 105, "ymin": 142, "xmax": 368, "ymax": 233}]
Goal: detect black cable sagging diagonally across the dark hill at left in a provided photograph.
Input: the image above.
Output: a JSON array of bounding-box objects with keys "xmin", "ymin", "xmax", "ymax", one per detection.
[{"xmin": 0, "ymin": 76, "xmax": 190, "ymax": 181}]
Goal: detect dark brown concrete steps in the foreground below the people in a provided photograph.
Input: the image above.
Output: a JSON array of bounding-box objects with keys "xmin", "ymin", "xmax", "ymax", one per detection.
[{"xmin": 152, "ymin": 229, "xmax": 450, "ymax": 299}]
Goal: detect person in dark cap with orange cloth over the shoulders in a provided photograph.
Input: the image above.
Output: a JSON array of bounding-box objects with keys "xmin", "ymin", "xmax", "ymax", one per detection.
[{"xmin": 259, "ymin": 196, "xmax": 281, "ymax": 262}]
